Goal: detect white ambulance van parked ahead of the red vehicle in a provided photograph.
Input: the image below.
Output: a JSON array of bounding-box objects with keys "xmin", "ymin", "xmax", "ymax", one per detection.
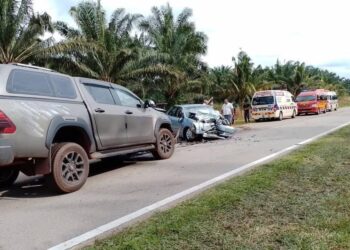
[{"xmin": 252, "ymin": 90, "xmax": 298, "ymax": 121}]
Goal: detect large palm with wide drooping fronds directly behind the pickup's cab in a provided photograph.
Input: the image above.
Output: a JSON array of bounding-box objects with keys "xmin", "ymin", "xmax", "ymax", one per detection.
[{"xmin": 51, "ymin": 0, "xmax": 174, "ymax": 85}]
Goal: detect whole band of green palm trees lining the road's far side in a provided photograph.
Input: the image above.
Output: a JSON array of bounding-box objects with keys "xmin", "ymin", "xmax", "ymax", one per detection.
[{"xmin": 0, "ymin": 0, "xmax": 350, "ymax": 106}]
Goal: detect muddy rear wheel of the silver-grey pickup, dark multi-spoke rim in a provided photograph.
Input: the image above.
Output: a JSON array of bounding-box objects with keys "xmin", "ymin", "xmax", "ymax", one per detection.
[{"xmin": 46, "ymin": 142, "xmax": 90, "ymax": 193}]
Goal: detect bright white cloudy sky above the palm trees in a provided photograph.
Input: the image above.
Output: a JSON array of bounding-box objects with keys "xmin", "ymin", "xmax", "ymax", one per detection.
[{"xmin": 33, "ymin": 0, "xmax": 350, "ymax": 78}]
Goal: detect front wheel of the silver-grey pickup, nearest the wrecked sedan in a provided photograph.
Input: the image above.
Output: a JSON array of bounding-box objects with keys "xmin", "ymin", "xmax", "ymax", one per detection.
[{"xmin": 152, "ymin": 128, "xmax": 175, "ymax": 160}]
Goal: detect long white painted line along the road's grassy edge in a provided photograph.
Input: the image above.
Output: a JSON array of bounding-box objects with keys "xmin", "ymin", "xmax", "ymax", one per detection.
[{"xmin": 49, "ymin": 122, "xmax": 350, "ymax": 250}]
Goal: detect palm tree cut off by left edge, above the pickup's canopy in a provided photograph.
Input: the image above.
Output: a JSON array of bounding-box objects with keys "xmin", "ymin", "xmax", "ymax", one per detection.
[{"xmin": 0, "ymin": 0, "xmax": 53, "ymax": 63}]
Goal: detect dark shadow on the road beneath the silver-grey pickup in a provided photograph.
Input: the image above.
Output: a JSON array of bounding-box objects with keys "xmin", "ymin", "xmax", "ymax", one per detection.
[{"xmin": 0, "ymin": 154, "xmax": 154, "ymax": 201}]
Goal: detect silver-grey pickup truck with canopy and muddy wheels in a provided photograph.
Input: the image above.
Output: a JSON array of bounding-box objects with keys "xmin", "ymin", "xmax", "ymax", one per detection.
[{"xmin": 0, "ymin": 64, "xmax": 175, "ymax": 193}]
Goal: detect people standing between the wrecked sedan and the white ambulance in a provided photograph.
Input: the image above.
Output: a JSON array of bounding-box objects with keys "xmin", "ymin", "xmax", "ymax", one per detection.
[{"xmin": 203, "ymin": 97, "xmax": 250, "ymax": 124}]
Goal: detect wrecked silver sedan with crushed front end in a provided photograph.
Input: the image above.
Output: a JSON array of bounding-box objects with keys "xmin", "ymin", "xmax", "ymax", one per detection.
[{"xmin": 167, "ymin": 104, "xmax": 235, "ymax": 141}]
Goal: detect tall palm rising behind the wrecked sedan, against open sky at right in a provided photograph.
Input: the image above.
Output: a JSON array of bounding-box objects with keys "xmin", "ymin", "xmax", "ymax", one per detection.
[{"xmin": 140, "ymin": 4, "xmax": 207, "ymax": 105}]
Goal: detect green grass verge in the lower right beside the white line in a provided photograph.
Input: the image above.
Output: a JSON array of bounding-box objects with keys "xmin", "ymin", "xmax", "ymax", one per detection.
[{"xmin": 89, "ymin": 127, "xmax": 350, "ymax": 250}]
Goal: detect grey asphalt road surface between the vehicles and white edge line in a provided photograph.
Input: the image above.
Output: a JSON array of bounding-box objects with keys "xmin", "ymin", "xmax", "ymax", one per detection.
[{"xmin": 0, "ymin": 108, "xmax": 350, "ymax": 249}]
